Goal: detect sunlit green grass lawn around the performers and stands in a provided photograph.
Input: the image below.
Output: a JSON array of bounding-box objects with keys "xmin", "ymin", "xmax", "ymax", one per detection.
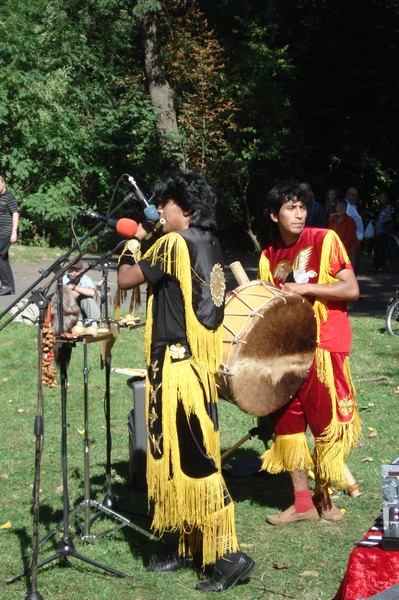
[{"xmin": 0, "ymin": 316, "xmax": 399, "ymax": 600}]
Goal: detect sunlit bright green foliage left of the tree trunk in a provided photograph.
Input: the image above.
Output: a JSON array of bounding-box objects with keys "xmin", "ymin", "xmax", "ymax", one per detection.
[{"xmin": 0, "ymin": 0, "xmax": 166, "ymax": 244}]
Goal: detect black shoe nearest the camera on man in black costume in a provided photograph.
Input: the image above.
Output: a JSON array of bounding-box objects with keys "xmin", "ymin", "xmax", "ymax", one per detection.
[{"xmin": 195, "ymin": 552, "xmax": 255, "ymax": 592}]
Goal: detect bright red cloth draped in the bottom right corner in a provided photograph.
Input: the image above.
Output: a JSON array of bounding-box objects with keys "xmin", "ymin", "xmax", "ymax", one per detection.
[{"xmin": 333, "ymin": 530, "xmax": 399, "ymax": 600}]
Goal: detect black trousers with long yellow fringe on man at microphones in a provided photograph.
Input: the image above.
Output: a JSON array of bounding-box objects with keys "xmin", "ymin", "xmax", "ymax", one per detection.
[{"xmin": 147, "ymin": 349, "xmax": 238, "ymax": 565}]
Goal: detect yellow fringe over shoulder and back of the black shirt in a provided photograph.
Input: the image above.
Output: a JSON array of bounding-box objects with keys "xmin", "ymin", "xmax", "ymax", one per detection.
[{"xmin": 144, "ymin": 233, "xmax": 223, "ymax": 373}]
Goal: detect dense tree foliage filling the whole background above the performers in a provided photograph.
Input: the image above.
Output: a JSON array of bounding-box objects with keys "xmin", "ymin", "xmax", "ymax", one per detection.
[{"xmin": 0, "ymin": 0, "xmax": 399, "ymax": 250}]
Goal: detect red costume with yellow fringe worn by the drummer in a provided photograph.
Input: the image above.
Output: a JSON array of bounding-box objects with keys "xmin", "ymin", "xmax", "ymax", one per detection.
[{"xmin": 258, "ymin": 228, "xmax": 361, "ymax": 493}]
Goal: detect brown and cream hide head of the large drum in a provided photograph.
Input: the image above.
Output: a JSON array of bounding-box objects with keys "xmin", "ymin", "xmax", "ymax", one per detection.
[{"xmin": 217, "ymin": 286, "xmax": 316, "ymax": 417}]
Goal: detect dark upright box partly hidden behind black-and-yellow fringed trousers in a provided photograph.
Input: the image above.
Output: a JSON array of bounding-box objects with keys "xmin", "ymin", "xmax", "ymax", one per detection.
[{"xmin": 127, "ymin": 376, "xmax": 147, "ymax": 490}]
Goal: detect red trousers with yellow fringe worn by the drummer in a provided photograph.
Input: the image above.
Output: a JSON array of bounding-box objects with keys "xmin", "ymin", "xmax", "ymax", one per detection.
[{"xmin": 262, "ymin": 348, "xmax": 361, "ymax": 494}]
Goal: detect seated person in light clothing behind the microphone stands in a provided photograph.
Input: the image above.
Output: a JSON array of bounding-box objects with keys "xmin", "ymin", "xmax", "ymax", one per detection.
[{"xmin": 62, "ymin": 261, "xmax": 101, "ymax": 324}]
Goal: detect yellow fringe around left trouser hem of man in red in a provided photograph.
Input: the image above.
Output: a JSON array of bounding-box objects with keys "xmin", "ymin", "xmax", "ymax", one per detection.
[{"xmin": 261, "ymin": 433, "xmax": 314, "ymax": 475}]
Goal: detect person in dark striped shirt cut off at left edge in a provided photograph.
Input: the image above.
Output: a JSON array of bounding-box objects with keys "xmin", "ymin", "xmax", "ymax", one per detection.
[{"xmin": 0, "ymin": 177, "xmax": 19, "ymax": 296}]
